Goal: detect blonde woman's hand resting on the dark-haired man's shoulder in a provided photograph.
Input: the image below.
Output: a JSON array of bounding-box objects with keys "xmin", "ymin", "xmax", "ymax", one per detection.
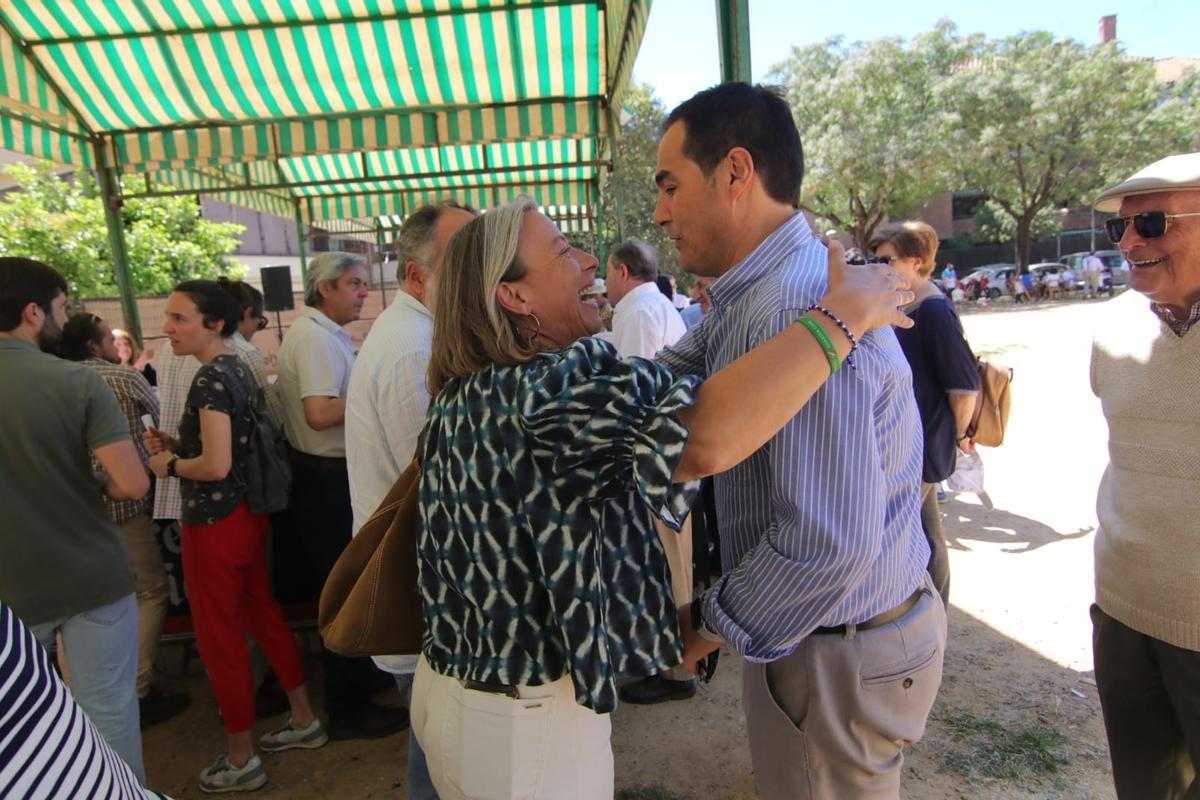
[{"xmin": 821, "ymin": 240, "xmax": 914, "ymax": 336}]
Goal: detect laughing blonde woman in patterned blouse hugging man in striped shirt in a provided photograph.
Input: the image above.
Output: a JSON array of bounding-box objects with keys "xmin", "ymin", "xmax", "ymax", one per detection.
[{"xmin": 412, "ymin": 199, "xmax": 911, "ymax": 800}]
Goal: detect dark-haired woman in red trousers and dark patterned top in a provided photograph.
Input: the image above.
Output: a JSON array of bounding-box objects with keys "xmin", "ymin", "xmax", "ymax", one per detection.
[{"xmin": 144, "ymin": 281, "xmax": 329, "ymax": 792}]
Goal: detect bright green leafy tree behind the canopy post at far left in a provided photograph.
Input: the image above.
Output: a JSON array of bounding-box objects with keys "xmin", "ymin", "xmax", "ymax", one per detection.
[{"xmin": 0, "ymin": 163, "xmax": 244, "ymax": 297}]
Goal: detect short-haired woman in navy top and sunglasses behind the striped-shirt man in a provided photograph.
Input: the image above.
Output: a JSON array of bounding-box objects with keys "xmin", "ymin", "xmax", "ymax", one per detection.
[{"xmin": 871, "ymin": 222, "xmax": 979, "ymax": 603}]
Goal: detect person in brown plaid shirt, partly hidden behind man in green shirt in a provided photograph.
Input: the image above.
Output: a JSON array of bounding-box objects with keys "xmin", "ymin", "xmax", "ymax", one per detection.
[{"xmin": 61, "ymin": 312, "xmax": 191, "ymax": 728}]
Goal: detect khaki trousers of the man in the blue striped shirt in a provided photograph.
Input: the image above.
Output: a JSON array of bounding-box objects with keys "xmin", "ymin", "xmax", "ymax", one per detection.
[{"xmin": 742, "ymin": 578, "xmax": 946, "ymax": 800}]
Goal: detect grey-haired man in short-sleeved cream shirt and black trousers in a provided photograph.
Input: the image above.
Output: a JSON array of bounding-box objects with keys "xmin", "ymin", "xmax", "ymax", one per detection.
[{"xmin": 277, "ymin": 253, "xmax": 408, "ymax": 739}]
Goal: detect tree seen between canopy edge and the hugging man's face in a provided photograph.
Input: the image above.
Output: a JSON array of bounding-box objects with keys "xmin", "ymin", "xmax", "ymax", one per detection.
[{"xmin": 600, "ymin": 84, "xmax": 691, "ymax": 289}]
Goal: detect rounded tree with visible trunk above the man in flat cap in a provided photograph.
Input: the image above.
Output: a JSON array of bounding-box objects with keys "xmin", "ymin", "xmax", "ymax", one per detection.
[{"xmin": 942, "ymin": 32, "xmax": 1187, "ymax": 267}]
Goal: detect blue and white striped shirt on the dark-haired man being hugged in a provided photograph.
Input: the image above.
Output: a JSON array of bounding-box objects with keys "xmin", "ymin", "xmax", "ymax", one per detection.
[{"xmin": 656, "ymin": 213, "xmax": 929, "ymax": 662}]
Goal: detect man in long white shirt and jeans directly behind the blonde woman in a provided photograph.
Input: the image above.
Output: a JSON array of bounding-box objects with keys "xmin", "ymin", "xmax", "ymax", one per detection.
[{"xmin": 346, "ymin": 201, "xmax": 475, "ymax": 800}]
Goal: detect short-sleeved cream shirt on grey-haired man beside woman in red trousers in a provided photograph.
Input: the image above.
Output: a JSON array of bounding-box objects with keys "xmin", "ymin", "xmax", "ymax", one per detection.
[{"xmin": 276, "ymin": 306, "xmax": 354, "ymax": 458}]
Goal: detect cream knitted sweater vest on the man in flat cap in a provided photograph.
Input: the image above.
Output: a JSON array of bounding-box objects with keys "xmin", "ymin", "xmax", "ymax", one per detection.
[{"xmin": 1092, "ymin": 290, "xmax": 1200, "ymax": 651}]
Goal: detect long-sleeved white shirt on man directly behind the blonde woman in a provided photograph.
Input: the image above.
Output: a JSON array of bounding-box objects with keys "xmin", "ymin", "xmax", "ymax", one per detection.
[{"xmin": 346, "ymin": 291, "xmax": 433, "ymax": 674}]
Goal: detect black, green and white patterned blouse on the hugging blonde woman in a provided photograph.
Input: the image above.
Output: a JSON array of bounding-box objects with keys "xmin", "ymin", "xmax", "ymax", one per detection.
[{"xmin": 418, "ymin": 337, "xmax": 700, "ymax": 712}]
